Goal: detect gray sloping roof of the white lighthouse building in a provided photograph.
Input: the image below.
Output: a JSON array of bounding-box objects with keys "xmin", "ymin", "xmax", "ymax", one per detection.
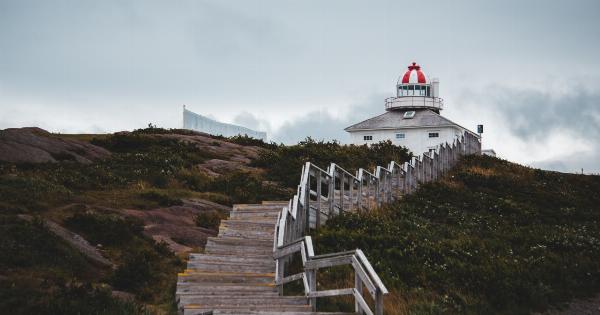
[{"xmin": 344, "ymin": 109, "xmax": 466, "ymax": 132}]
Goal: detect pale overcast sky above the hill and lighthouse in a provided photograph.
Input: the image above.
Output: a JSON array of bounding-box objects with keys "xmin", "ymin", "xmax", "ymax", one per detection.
[{"xmin": 0, "ymin": 0, "xmax": 600, "ymax": 172}]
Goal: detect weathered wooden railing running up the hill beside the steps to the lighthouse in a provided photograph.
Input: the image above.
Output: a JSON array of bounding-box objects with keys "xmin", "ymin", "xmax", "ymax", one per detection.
[{"xmin": 273, "ymin": 132, "xmax": 481, "ymax": 315}]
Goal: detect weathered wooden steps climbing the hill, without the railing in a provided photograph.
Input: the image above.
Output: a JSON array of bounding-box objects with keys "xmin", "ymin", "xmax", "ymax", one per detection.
[{"xmin": 176, "ymin": 201, "xmax": 354, "ymax": 315}]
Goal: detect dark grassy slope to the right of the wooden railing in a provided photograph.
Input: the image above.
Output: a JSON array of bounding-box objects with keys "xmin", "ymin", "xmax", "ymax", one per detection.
[{"xmin": 315, "ymin": 156, "xmax": 600, "ymax": 314}]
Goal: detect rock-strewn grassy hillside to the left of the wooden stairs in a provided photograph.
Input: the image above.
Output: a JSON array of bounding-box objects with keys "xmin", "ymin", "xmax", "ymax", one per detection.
[{"xmin": 0, "ymin": 127, "xmax": 408, "ymax": 314}]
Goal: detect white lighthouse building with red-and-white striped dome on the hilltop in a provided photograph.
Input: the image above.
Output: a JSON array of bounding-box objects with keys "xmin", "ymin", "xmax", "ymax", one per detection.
[{"xmin": 344, "ymin": 62, "xmax": 478, "ymax": 155}]
